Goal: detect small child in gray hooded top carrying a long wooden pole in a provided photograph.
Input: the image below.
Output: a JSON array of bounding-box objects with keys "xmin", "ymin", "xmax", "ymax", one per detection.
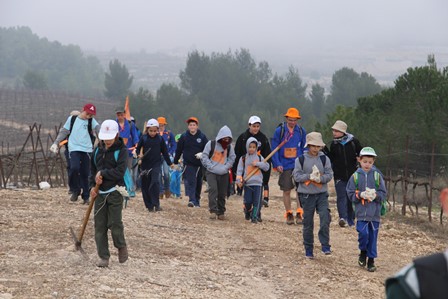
[{"xmin": 236, "ymin": 137, "xmax": 269, "ymax": 223}]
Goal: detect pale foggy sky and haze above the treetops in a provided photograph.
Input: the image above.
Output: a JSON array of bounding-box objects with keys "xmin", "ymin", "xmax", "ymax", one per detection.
[{"xmin": 0, "ymin": 0, "xmax": 448, "ymax": 90}]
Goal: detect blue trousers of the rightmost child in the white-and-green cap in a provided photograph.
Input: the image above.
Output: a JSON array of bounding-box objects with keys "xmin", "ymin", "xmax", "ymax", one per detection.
[{"xmin": 356, "ymin": 220, "xmax": 380, "ymax": 258}]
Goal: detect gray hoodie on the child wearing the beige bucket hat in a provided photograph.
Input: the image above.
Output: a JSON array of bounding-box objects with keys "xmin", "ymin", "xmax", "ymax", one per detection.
[{"xmin": 292, "ymin": 152, "xmax": 333, "ymax": 194}]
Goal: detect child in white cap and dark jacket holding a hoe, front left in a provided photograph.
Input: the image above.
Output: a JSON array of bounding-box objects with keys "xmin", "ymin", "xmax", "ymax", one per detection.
[{"xmin": 90, "ymin": 119, "xmax": 128, "ymax": 267}]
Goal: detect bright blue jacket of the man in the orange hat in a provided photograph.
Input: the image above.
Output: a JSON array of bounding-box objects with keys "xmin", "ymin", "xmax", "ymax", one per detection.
[{"xmin": 271, "ymin": 123, "xmax": 306, "ymax": 170}]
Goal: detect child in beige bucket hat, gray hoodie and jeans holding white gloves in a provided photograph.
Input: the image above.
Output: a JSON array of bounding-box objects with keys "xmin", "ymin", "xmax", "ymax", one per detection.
[{"xmin": 293, "ymin": 132, "xmax": 333, "ymax": 259}]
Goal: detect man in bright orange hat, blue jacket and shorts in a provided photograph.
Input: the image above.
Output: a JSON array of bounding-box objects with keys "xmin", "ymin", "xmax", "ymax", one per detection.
[{"xmin": 271, "ymin": 108, "xmax": 306, "ymax": 225}]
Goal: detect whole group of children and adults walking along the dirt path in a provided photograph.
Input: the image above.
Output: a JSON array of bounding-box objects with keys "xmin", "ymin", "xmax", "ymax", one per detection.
[{"xmin": 51, "ymin": 104, "xmax": 386, "ymax": 271}]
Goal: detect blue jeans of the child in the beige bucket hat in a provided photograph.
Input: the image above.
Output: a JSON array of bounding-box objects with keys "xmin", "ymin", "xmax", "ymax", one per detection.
[{"xmin": 299, "ymin": 192, "xmax": 330, "ymax": 251}]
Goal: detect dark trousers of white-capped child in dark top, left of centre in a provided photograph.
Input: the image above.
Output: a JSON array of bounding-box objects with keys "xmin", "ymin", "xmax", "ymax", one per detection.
[{"xmin": 140, "ymin": 166, "xmax": 160, "ymax": 210}]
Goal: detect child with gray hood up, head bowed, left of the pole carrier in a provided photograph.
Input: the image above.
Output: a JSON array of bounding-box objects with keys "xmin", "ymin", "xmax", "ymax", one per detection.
[{"xmin": 201, "ymin": 126, "xmax": 235, "ymax": 220}]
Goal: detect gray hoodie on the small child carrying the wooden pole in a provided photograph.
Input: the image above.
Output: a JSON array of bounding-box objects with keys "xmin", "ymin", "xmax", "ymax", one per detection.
[{"xmin": 236, "ymin": 137, "xmax": 269, "ymax": 186}]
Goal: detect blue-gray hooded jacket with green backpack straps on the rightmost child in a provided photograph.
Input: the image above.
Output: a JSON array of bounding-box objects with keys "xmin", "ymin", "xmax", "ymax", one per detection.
[{"xmin": 347, "ymin": 166, "xmax": 386, "ymax": 222}]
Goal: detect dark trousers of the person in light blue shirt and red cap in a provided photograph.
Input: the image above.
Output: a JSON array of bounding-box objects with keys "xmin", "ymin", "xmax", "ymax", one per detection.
[{"xmin": 69, "ymin": 151, "xmax": 90, "ymax": 200}]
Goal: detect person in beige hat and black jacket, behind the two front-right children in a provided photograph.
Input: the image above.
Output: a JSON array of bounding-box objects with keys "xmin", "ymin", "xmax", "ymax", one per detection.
[{"xmin": 327, "ymin": 120, "xmax": 362, "ymax": 227}]
